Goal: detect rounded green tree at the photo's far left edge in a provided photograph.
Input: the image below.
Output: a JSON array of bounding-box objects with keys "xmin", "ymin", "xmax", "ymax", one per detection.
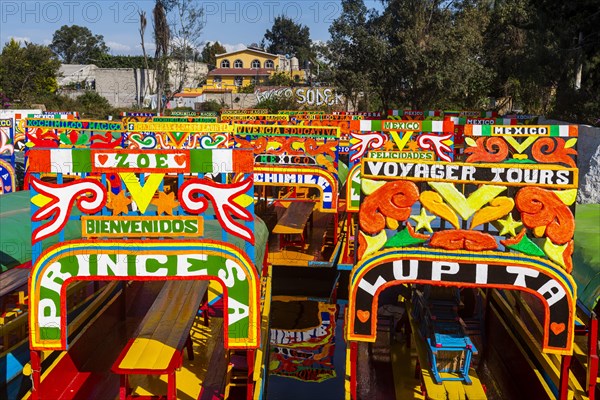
[{"xmin": 0, "ymin": 39, "xmax": 60, "ymax": 104}]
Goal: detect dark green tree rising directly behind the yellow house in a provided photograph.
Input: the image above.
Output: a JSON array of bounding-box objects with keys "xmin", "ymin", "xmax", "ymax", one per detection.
[{"xmin": 263, "ymin": 16, "xmax": 315, "ymax": 64}]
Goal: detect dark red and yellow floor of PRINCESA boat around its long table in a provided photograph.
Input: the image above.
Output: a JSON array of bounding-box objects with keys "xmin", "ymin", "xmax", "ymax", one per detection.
[{"xmin": 25, "ymin": 282, "xmax": 227, "ymax": 399}]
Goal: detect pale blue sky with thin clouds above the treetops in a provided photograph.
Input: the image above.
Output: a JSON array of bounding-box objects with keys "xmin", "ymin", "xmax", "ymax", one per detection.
[{"xmin": 0, "ymin": 0, "xmax": 376, "ymax": 54}]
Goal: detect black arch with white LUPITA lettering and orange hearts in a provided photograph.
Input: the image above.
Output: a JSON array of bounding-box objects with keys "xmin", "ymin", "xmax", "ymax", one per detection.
[{"xmin": 347, "ymin": 249, "xmax": 576, "ymax": 354}]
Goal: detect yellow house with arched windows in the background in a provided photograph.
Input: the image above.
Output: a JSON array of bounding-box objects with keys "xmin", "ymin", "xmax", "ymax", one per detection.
[{"xmin": 202, "ymin": 47, "xmax": 306, "ymax": 93}]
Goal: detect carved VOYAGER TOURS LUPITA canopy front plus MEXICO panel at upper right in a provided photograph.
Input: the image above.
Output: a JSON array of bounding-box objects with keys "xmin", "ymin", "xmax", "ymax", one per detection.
[{"xmin": 346, "ymin": 125, "xmax": 578, "ymax": 355}]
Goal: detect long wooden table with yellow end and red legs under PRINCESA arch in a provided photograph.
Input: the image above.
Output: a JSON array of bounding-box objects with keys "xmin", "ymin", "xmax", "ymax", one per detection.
[{"xmin": 112, "ymin": 280, "xmax": 208, "ymax": 400}]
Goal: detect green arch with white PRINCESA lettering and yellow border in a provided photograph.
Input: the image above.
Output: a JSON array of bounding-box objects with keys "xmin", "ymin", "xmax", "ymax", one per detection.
[{"xmin": 29, "ymin": 240, "xmax": 260, "ymax": 350}]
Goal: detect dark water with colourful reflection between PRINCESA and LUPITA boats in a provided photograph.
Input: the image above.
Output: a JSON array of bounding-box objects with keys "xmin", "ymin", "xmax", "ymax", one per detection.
[{"xmin": 266, "ymin": 301, "xmax": 346, "ymax": 400}]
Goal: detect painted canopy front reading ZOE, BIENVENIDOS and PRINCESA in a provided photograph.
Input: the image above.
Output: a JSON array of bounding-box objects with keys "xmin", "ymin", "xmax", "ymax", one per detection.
[{"xmin": 29, "ymin": 148, "xmax": 260, "ymax": 350}]
